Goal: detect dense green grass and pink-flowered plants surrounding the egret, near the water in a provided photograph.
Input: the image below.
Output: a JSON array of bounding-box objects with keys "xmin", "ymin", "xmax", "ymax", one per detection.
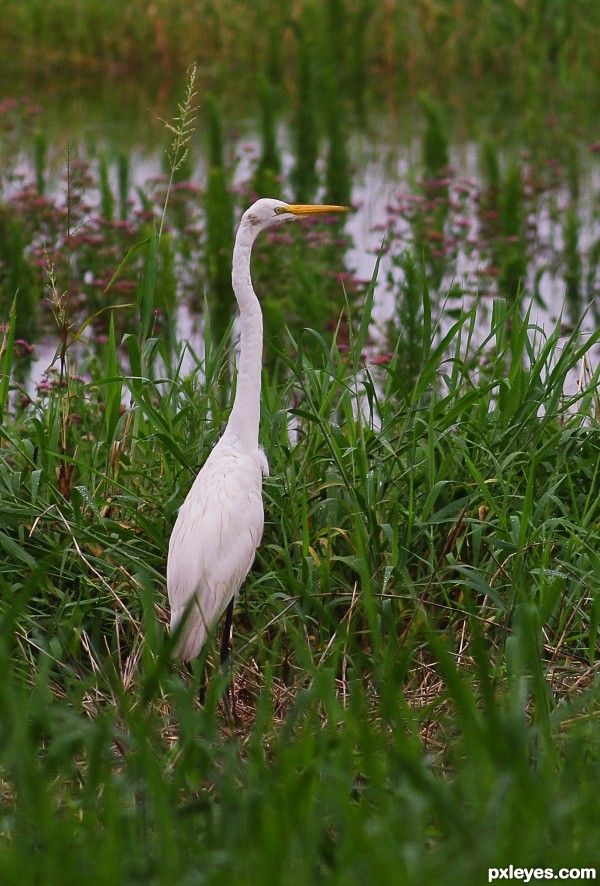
[{"xmin": 0, "ymin": 55, "xmax": 600, "ymax": 886}]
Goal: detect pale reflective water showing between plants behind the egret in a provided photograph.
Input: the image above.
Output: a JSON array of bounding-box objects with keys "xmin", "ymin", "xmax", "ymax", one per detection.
[{"xmin": 3, "ymin": 87, "xmax": 600, "ymax": 391}]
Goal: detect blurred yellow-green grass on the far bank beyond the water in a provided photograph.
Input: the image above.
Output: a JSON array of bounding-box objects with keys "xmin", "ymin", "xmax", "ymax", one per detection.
[{"xmin": 0, "ymin": 0, "xmax": 598, "ymax": 108}]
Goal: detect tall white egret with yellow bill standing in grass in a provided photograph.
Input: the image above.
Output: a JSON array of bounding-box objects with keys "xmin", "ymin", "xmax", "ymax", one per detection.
[{"xmin": 167, "ymin": 198, "xmax": 348, "ymax": 664}]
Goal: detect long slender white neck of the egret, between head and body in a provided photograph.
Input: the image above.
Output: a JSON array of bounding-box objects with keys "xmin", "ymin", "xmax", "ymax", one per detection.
[{"xmin": 225, "ymin": 229, "xmax": 263, "ymax": 449}]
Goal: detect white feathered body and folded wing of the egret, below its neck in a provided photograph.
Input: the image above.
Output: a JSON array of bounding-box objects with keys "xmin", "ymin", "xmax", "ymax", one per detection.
[{"xmin": 167, "ymin": 443, "xmax": 264, "ymax": 660}]
